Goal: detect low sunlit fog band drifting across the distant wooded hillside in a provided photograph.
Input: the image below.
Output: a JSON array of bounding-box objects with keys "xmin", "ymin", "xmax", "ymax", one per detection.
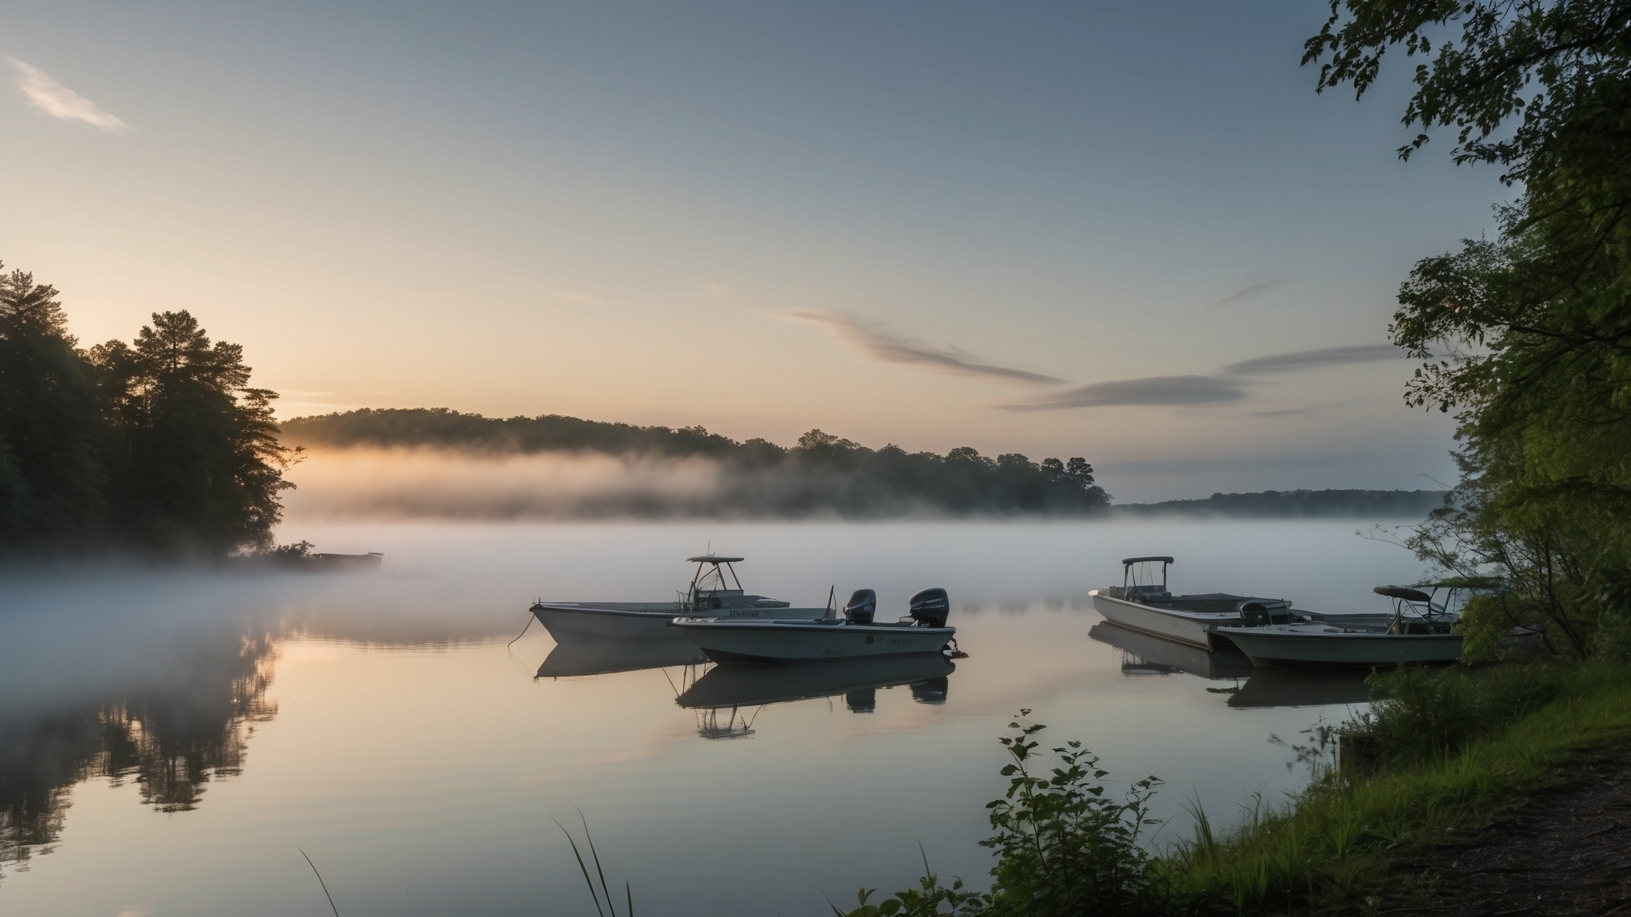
[{"xmin": 284, "ymin": 447, "xmax": 1096, "ymax": 521}]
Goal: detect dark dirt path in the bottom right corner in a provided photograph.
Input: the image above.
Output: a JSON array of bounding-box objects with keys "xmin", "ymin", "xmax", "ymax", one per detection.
[{"xmin": 1381, "ymin": 749, "xmax": 1631, "ymax": 917}]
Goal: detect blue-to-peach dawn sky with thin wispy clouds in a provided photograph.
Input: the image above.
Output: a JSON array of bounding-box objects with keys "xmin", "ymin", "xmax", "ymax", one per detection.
[{"xmin": 0, "ymin": 0, "xmax": 1512, "ymax": 501}]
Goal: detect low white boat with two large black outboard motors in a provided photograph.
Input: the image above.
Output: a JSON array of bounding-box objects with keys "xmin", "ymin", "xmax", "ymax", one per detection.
[{"xmin": 674, "ymin": 589, "xmax": 957, "ymax": 662}]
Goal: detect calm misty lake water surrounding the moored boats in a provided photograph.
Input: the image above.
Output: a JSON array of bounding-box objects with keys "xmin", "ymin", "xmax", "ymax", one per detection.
[{"xmin": 0, "ymin": 521, "xmax": 1421, "ymax": 917}]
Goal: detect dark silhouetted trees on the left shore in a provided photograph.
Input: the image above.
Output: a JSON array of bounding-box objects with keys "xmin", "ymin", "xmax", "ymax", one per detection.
[{"xmin": 0, "ymin": 261, "xmax": 295, "ymax": 553}]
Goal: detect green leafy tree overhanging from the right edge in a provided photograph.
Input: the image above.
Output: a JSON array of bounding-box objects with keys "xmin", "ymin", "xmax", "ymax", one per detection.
[{"xmin": 1305, "ymin": 0, "xmax": 1631, "ymax": 654}]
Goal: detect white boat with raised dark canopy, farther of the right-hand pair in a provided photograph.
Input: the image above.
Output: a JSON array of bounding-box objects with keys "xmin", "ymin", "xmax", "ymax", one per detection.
[{"xmin": 1088, "ymin": 556, "xmax": 1302, "ymax": 651}]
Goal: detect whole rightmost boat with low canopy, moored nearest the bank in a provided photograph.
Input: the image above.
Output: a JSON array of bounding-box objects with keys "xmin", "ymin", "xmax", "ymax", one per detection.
[{"xmin": 1218, "ymin": 586, "xmax": 1461, "ymax": 667}]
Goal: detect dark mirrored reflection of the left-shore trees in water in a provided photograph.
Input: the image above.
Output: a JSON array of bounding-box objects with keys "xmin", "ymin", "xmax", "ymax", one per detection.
[{"xmin": 0, "ymin": 635, "xmax": 277, "ymax": 870}]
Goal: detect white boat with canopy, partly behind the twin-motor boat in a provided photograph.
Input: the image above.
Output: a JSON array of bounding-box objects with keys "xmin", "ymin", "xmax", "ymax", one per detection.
[{"xmin": 532, "ymin": 555, "xmax": 827, "ymax": 643}]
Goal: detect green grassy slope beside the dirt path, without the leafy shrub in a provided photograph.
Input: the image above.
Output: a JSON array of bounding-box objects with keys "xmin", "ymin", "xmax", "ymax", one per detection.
[{"xmin": 1153, "ymin": 664, "xmax": 1631, "ymax": 914}]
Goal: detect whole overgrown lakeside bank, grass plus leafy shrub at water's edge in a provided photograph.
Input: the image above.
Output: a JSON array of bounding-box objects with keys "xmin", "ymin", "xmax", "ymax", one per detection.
[{"xmin": 833, "ymin": 662, "xmax": 1631, "ymax": 917}]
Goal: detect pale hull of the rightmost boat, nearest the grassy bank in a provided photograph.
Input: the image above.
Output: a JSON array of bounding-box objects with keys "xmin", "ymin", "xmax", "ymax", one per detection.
[{"xmin": 1218, "ymin": 628, "xmax": 1461, "ymax": 669}]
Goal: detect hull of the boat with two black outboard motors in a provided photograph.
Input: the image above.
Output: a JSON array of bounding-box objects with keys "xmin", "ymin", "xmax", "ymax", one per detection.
[{"xmin": 675, "ymin": 620, "xmax": 957, "ymax": 662}]
